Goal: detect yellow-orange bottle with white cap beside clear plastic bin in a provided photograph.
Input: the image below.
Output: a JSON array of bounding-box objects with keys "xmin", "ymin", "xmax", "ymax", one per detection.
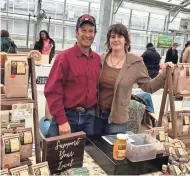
[{"xmin": 113, "ymin": 134, "xmax": 127, "ymax": 160}]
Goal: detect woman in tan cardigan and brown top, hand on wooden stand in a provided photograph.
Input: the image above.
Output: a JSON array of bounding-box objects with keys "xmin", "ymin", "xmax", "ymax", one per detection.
[{"xmin": 95, "ymin": 24, "xmax": 173, "ymax": 134}]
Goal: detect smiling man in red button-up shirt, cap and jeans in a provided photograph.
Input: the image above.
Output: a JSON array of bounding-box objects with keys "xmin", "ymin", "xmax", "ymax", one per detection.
[{"xmin": 44, "ymin": 15, "xmax": 100, "ymax": 136}]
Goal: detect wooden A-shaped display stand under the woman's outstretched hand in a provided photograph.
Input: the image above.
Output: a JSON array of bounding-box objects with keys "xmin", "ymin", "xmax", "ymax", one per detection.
[{"xmin": 157, "ymin": 67, "xmax": 190, "ymax": 148}]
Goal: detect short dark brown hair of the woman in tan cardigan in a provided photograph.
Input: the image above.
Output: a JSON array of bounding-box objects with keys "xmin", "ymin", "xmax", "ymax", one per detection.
[{"xmin": 106, "ymin": 24, "xmax": 131, "ymax": 52}]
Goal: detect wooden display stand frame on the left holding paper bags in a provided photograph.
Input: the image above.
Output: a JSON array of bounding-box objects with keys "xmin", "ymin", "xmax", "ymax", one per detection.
[{"xmin": 0, "ymin": 56, "xmax": 41, "ymax": 164}]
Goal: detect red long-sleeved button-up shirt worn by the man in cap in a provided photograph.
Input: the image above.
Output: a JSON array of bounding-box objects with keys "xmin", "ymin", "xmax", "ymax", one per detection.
[{"xmin": 44, "ymin": 44, "xmax": 100, "ymax": 125}]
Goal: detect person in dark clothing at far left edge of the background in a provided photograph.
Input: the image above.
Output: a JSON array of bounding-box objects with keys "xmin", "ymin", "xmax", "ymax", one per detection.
[{"xmin": 1, "ymin": 30, "xmax": 17, "ymax": 53}]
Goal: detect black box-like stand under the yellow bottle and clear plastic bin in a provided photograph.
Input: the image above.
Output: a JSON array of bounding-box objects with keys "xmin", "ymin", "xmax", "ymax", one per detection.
[{"xmin": 85, "ymin": 136, "xmax": 169, "ymax": 175}]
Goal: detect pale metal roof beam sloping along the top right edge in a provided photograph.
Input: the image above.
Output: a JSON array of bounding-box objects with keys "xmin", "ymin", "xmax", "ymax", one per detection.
[{"xmin": 124, "ymin": 0, "xmax": 190, "ymax": 13}]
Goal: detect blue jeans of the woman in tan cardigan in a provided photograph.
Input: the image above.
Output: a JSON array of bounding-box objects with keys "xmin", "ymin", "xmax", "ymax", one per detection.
[{"xmin": 94, "ymin": 110, "xmax": 127, "ymax": 135}]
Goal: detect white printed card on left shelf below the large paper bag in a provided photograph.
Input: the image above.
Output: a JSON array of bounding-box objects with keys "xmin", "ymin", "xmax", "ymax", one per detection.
[{"xmin": 11, "ymin": 103, "xmax": 33, "ymax": 121}]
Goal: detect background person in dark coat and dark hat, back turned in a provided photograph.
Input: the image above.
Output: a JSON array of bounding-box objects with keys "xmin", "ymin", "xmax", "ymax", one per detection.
[{"xmin": 141, "ymin": 43, "xmax": 161, "ymax": 79}]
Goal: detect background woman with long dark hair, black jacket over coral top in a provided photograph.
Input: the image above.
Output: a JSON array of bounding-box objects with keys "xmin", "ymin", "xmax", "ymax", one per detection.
[{"xmin": 34, "ymin": 30, "xmax": 55, "ymax": 64}]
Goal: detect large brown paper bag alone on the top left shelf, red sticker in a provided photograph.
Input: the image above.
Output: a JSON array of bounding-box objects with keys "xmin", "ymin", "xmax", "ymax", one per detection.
[{"xmin": 5, "ymin": 54, "xmax": 28, "ymax": 98}]
